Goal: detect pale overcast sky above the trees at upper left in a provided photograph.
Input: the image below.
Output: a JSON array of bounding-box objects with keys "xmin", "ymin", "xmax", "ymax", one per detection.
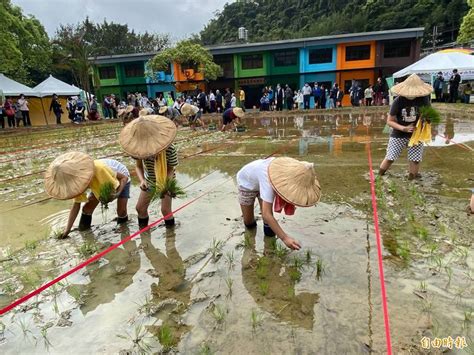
[{"xmin": 12, "ymin": 0, "xmax": 234, "ymax": 40}]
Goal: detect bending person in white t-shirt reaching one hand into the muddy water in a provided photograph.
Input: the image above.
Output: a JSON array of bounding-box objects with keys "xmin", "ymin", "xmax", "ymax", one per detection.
[{"xmin": 237, "ymin": 158, "xmax": 321, "ymax": 250}]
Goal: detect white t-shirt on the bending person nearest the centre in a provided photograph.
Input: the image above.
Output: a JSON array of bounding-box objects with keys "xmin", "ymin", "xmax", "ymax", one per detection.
[{"xmin": 237, "ymin": 158, "xmax": 275, "ymax": 203}]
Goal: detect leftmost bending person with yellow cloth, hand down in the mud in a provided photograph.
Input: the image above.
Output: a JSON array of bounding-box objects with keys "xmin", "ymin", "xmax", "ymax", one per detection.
[{"xmin": 45, "ymin": 152, "xmax": 130, "ymax": 238}]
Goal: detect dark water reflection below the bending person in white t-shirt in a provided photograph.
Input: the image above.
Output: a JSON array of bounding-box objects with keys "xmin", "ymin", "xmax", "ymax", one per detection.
[{"xmin": 242, "ymin": 230, "xmax": 319, "ymax": 330}]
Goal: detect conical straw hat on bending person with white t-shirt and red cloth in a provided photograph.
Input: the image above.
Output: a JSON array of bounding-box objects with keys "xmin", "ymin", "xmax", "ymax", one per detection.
[{"xmin": 268, "ymin": 158, "xmax": 321, "ymax": 207}]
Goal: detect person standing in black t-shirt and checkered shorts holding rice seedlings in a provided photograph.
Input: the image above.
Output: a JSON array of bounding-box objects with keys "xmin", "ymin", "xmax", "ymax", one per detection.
[{"xmin": 379, "ymin": 74, "xmax": 433, "ymax": 180}]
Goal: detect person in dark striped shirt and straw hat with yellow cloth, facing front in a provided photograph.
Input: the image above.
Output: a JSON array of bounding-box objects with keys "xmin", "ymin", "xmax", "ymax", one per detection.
[{"xmin": 119, "ymin": 115, "xmax": 178, "ymax": 228}]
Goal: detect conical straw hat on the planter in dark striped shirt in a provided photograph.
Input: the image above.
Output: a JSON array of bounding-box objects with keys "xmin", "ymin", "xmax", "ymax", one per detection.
[{"xmin": 119, "ymin": 115, "xmax": 177, "ymax": 159}]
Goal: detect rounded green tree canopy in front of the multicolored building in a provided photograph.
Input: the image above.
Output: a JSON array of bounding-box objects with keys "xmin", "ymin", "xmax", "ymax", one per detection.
[{"xmin": 147, "ymin": 40, "xmax": 222, "ymax": 80}]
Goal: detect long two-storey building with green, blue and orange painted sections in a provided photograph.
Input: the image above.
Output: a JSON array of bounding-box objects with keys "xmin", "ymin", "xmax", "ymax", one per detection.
[{"xmin": 90, "ymin": 28, "xmax": 424, "ymax": 107}]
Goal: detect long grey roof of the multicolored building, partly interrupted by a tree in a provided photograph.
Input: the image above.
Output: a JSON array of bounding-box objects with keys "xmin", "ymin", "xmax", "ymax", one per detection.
[{"xmin": 90, "ymin": 27, "xmax": 424, "ymax": 64}]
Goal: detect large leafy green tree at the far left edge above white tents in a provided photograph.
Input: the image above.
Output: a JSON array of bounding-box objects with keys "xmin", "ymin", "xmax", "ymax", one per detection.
[{"xmin": 0, "ymin": 0, "xmax": 51, "ymax": 85}]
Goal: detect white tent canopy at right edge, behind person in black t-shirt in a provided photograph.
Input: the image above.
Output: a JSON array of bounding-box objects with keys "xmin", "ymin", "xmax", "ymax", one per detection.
[{"xmin": 393, "ymin": 50, "xmax": 474, "ymax": 80}]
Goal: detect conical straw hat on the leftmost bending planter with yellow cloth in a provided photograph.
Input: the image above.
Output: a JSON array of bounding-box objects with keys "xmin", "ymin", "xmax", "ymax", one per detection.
[{"xmin": 44, "ymin": 152, "xmax": 94, "ymax": 200}]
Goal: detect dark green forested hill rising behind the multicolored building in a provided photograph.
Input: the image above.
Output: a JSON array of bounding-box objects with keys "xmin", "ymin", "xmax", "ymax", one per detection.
[{"xmin": 200, "ymin": 0, "xmax": 468, "ymax": 45}]
